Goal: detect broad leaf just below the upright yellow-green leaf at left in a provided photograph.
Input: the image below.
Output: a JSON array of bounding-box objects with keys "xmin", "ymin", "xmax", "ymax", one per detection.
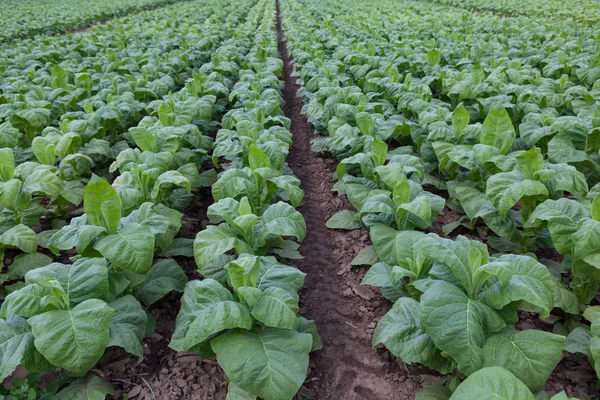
[{"xmin": 94, "ymin": 224, "xmax": 154, "ymax": 274}]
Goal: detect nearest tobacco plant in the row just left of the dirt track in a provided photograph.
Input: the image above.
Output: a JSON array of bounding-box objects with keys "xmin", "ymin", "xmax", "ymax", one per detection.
[{"xmin": 169, "ymin": 254, "xmax": 322, "ymax": 400}]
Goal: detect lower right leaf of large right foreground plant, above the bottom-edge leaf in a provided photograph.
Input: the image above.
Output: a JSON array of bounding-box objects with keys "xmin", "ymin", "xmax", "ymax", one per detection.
[{"xmin": 483, "ymin": 328, "xmax": 565, "ymax": 390}]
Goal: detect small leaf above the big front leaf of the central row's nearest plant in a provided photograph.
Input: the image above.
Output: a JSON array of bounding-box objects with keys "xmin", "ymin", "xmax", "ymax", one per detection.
[{"xmin": 252, "ymin": 287, "xmax": 298, "ymax": 330}]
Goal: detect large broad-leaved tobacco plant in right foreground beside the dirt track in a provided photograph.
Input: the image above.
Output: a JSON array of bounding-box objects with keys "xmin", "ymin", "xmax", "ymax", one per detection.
[{"xmin": 364, "ymin": 228, "xmax": 578, "ymax": 390}]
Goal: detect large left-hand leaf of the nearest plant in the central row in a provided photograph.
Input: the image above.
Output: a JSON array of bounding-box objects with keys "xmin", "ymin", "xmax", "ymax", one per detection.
[{"xmin": 169, "ymin": 279, "xmax": 252, "ymax": 351}]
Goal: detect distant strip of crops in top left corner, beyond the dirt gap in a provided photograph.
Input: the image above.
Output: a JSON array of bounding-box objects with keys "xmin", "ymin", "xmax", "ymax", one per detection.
[{"xmin": 0, "ymin": 0, "xmax": 186, "ymax": 45}]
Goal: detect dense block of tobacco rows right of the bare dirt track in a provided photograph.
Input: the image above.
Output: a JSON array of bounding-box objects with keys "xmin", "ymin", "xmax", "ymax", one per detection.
[{"xmin": 282, "ymin": 0, "xmax": 600, "ymax": 399}]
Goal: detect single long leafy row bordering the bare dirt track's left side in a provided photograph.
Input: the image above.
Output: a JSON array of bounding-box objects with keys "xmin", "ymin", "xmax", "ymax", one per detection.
[{"xmin": 170, "ymin": 1, "xmax": 321, "ymax": 400}]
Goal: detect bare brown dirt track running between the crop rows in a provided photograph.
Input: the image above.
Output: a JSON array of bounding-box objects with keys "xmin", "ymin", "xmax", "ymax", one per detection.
[{"xmin": 277, "ymin": 3, "xmax": 420, "ymax": 400}]
